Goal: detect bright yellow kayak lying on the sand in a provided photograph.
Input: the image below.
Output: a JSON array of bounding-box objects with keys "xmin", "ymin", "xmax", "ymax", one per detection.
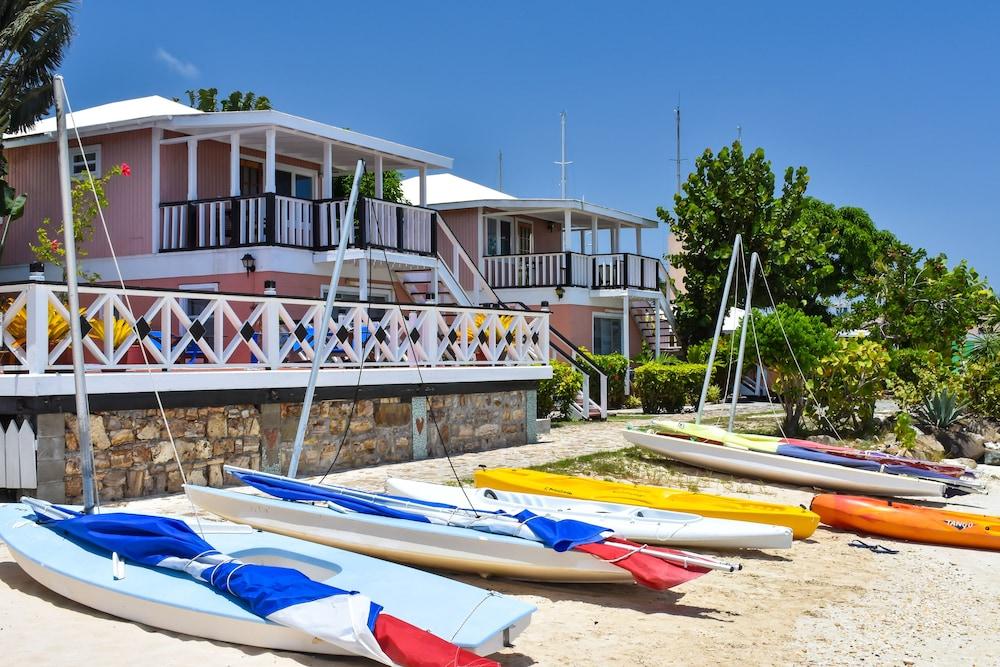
[{"xmin": 475, "ymin": 468, "xmax": 819, "ymax": 540}]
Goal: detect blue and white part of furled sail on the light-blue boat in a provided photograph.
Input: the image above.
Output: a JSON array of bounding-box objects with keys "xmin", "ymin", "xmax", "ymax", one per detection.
[{"xmin": 36, "ymin": 506, "xmax": 392, "ymax": 664}]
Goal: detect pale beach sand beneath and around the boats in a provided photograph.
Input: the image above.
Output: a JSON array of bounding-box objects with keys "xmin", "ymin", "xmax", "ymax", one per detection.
[{"xmin": 0, "ymin": 424, "xmax": 1000, "ymax": 667}]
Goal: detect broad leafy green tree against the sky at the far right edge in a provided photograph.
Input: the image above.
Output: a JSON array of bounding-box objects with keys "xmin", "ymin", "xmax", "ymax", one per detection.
[{"xmin": 843, "ymin": 242, "xmax": 997, "ymax": 357}]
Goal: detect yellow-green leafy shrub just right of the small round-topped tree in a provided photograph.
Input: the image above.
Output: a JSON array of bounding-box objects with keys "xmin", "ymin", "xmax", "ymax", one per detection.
[{"xmin": 808, "ymin": 339, "xmax": 889, "ymax": 436}]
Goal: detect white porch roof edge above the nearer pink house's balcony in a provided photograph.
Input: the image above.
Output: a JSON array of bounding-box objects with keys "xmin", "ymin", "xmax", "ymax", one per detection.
[{"xmin": 157, "ymin": 110, "xmax": 454, "ymax": 169}]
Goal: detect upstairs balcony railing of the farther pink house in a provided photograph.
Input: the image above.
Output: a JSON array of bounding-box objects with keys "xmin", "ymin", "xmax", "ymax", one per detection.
[{"xmin": 483, "ymin": 252, "xmax": 667, "ymax": 290}]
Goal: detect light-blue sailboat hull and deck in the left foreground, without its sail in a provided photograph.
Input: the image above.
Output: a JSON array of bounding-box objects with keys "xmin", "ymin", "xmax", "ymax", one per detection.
[{"xmin": 0, "ymin": 504, "xmax": 533, "ymax": 655}]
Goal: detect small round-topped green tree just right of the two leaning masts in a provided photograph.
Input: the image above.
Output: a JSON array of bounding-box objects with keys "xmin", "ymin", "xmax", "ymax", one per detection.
[{"xmin": 748, "ymin": 303, "xmax": 836, "ymax": 436}]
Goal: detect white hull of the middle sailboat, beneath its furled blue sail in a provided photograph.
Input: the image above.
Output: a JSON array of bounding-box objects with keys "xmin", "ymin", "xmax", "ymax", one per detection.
[{"xmin": 185, "ymin": 485, "xmax": 633, "ymax": 583}]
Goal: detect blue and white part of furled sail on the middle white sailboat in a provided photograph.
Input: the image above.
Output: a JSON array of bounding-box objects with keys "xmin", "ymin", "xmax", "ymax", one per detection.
[{"xmin": 229, "ymin": 470, "xmax": 610, "ymax": 552}]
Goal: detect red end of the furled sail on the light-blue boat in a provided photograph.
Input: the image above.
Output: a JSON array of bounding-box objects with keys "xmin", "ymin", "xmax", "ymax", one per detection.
[{"xmin": 375, "ymin": 612, "xmax": 500, "ymax": 667}]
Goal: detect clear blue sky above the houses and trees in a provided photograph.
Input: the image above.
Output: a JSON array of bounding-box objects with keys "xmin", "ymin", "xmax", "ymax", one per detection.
[{"xmin": 63, "ymin": 0, "xmax": 1000, "ymax": 284}]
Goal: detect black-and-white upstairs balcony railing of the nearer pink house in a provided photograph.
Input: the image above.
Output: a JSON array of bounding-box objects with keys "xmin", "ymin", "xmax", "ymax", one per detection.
[{"xmin": 158, "ymin": 194, "xmax": 437, "ymax": 255}]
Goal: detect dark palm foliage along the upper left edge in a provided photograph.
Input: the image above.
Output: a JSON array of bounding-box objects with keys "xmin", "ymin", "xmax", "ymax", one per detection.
[{"xmin": 0, "ymin": 0, "xmax": 76, "ymax": 255}]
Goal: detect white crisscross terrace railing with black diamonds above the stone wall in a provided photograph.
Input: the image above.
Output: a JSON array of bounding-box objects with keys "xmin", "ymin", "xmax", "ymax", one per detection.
[{"xmin": 0, "ymin": 283, "xmax": 549, "ymax": 373}]
